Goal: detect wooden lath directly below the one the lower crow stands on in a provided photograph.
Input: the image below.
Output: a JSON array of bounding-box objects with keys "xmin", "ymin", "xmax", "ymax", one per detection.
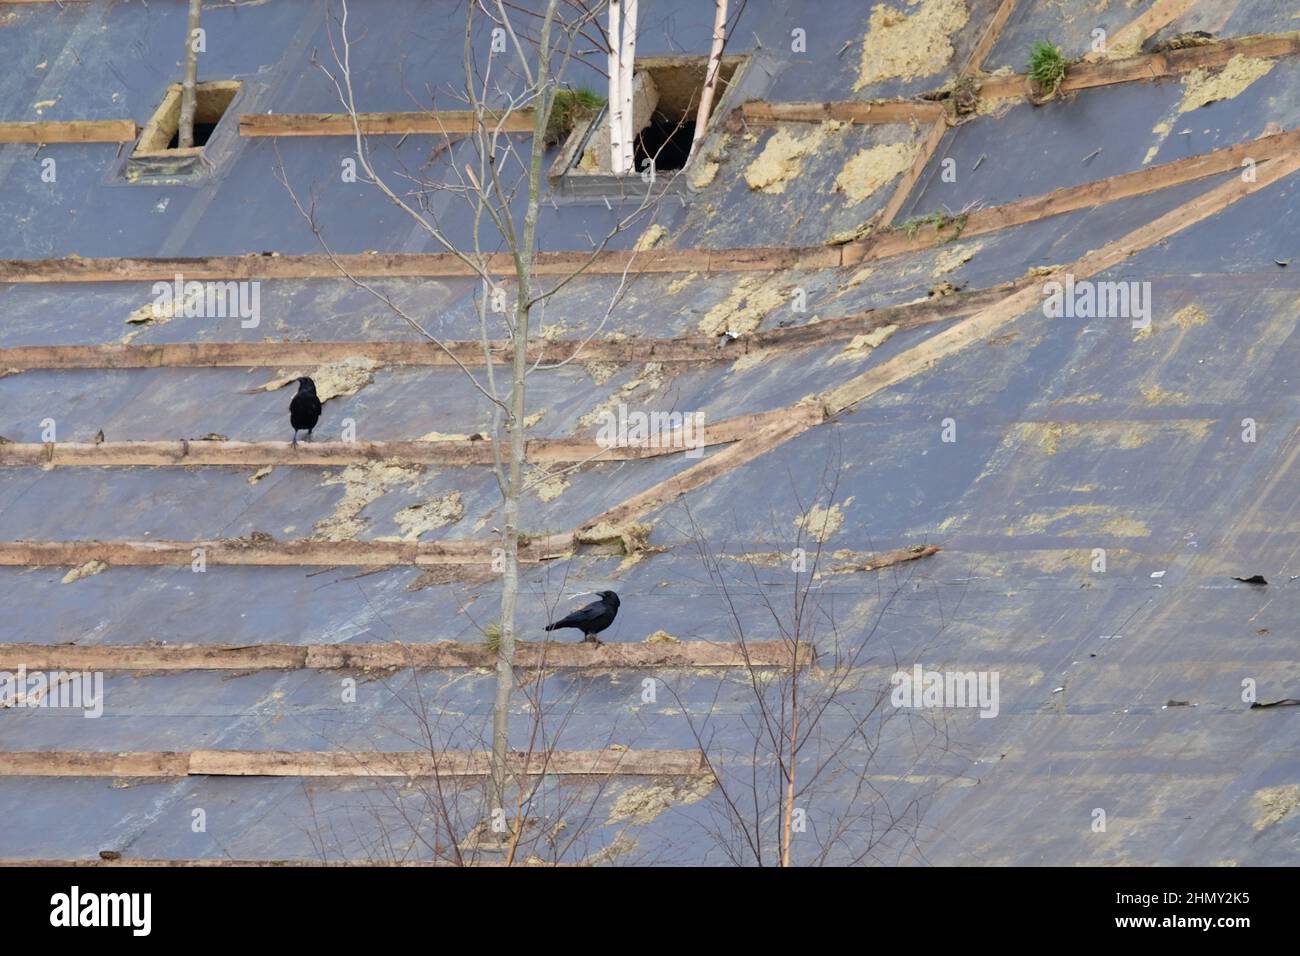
[{"xmin": 0, "ymin": 749, "xmax": 707, "ymax": 778}]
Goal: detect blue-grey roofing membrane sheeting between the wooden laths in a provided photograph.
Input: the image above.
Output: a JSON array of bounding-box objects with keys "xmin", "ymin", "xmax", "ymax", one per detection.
[{"xmin": 0, "ymin": 0, "xmax": 1300, "ymax": 865}]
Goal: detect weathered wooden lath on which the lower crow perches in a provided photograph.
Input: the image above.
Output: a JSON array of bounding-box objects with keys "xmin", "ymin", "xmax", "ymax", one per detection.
[{"xmin": 0, "ymin": 640, "xmax": 813, "ymax": 672}]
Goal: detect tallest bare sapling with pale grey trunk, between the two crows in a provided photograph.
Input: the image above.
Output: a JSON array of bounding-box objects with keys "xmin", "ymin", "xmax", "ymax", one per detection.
[{"xmin": 276, "ymin": 0, "xmax": 667, "ymax": 845}]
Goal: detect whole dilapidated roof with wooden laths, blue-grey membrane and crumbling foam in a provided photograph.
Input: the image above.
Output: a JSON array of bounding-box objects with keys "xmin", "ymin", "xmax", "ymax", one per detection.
[{"xmin": 0, "ymin": 0, "xmax": 1300, "ymax": 864}]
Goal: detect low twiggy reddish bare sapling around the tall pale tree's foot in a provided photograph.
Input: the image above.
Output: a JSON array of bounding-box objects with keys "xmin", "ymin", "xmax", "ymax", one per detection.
[{"xmin": 302, "ymin": 562, "xmax": 670, "ymax": 866}]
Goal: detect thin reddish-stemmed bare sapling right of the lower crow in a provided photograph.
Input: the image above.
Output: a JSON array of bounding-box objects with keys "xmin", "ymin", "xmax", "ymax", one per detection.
[{"xmin": 670, "ymin": 455, "xmax": 949, "ymax": 866}]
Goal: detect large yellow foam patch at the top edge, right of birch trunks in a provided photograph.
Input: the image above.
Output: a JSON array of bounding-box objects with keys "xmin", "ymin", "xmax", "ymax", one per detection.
[{"xmin": 853, "ymin": 0, "xmax": 970, "ymax": 92}]
